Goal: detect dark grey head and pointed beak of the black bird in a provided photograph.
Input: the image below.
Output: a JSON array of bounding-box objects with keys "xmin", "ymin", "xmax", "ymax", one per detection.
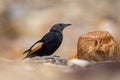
[{"xmin": 50, "ymin": 23, "xmax": 71, "ymax": 32}]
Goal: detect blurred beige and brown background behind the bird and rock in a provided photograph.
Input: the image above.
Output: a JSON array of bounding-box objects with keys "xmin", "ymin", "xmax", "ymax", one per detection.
[{"xmin": 0, "ymin": 0, "xmax": 120, "ymax": 59}]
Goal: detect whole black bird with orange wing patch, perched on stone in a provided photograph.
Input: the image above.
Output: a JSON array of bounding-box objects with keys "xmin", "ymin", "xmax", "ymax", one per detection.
[{"xmin": 23, "ymin": 23, "xmax": 71, "ymax": 59}]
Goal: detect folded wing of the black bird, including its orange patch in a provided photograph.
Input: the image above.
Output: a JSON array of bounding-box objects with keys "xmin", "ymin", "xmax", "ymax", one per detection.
[{"xmin": 23, "ymin": 32, "xmax": 55, "ymax": 54}]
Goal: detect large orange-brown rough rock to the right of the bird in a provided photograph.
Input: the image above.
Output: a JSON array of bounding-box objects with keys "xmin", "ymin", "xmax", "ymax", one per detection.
[{"xmin": 77, "ymin": 31, "xmax": 120, "ymax": 61}]
